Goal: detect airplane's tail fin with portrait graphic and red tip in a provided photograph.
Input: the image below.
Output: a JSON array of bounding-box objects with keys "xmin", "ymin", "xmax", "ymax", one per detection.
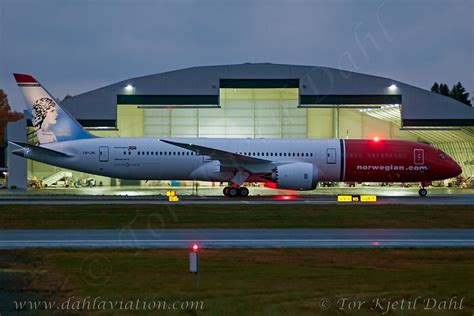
[{"xmin": 14, "ymin": 74, "xmax": 95, "ymax": 144}]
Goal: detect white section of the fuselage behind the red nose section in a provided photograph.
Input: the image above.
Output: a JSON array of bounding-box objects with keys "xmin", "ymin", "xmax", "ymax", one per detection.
[{"xmin": 25, "ymin": 138, "xmax": 343, "ymax": 181}]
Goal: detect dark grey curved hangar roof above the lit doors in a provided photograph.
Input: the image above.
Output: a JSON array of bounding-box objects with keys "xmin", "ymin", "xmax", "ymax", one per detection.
[{"xmin": 63, "ymin": 63, "xmax": 474, "ymax": 126}]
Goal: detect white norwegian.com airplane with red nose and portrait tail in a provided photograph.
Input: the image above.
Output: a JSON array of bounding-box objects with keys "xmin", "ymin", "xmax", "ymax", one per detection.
[{"xmin": 10, "ymin": 73, "xmax": 462, "ymax": 197}]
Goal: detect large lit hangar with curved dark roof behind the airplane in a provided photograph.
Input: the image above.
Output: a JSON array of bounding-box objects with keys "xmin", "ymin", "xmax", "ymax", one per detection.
[{"xmin": 11, "ymin": 63, "xmax": 474, "ymax": 189}]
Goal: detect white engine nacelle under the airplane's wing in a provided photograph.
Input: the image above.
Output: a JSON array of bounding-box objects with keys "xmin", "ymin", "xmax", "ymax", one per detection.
[{"xmin": 272, "ymin": 162, "xmax": 318, "ymax": 190}]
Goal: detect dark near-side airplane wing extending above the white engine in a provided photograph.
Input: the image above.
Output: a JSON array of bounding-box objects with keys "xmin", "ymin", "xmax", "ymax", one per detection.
[{"xmin": 160, "ymin": 139, "xmax": 272, "ymax": 168}]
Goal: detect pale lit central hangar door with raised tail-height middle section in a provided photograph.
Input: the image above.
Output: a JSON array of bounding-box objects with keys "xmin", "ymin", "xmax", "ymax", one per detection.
[{"xmin": 139, "ymin": 79, "xmax": 307, "ymax": 138}]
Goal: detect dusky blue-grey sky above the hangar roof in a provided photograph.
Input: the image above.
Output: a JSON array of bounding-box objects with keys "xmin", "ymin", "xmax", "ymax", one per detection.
[{"xmin": 0, "ymin": 0, "xmax": 474, "ymax": 109}]
